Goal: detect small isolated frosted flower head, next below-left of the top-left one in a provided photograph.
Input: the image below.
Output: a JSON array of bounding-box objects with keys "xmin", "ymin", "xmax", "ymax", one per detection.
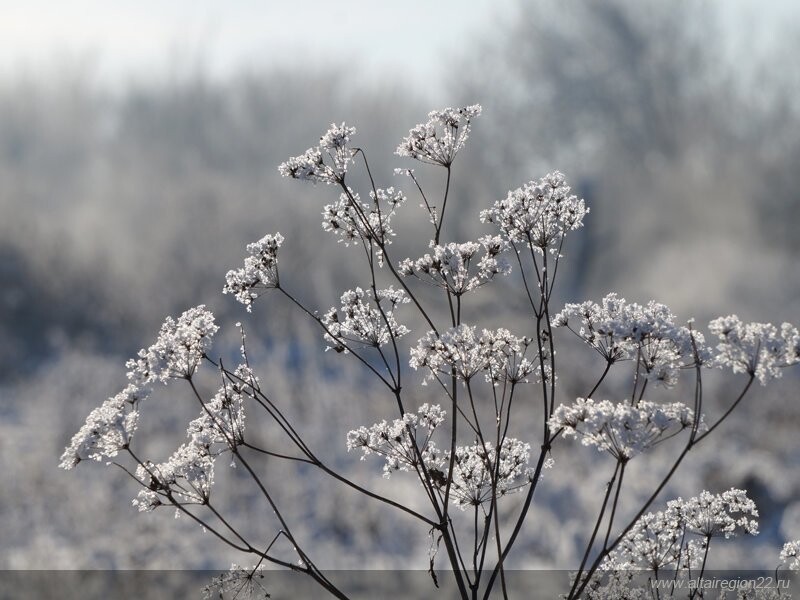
[{"xmin": 222, "ymin": 233, "xmax": 283, "ymax": 311}]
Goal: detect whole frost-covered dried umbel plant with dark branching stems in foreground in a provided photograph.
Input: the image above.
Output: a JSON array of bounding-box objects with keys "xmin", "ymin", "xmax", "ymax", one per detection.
[{"xmin": 61, "ymin": 105, "xmax": 800, "ymax": 600}]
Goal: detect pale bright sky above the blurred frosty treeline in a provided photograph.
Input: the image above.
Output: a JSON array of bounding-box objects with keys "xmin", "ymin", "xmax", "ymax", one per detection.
[{"xmin": 0, "ymin": 0, "xmax": 799, "ymax": 102}]
